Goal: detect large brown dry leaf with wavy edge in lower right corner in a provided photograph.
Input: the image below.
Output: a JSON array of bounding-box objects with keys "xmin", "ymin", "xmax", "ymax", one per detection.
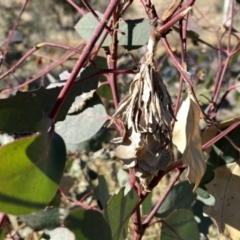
[{"xmin": 204, "ymin": 161, "xmax": 240, "ymax": 240}]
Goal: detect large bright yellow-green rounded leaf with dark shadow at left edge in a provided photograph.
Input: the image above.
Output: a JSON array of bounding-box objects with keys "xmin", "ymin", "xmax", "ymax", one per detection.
[{"xmin": 0, "ymin": 119, "xmax": 66, "ymax": 215}]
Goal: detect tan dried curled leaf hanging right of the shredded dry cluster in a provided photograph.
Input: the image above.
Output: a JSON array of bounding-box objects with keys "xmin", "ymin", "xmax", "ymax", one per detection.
[{"xmin": 172, "ymin": 92, "xmax": 206, "ymax": 191}]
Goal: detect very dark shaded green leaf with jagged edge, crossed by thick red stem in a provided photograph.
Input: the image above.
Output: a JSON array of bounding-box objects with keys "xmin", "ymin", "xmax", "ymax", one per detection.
[{"xmin": 0, "ymin": 65, "xmax": 99, "ymax": 133}]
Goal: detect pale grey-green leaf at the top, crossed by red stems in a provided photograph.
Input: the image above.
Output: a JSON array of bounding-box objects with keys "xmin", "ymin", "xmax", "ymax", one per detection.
[{"xmin": 75, "ymin": 12, "xmax": 150, "ymax": 50}]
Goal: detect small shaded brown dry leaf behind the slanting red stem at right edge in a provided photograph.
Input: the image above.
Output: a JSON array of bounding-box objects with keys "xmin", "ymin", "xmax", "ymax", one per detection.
[{"xmin": 202, "ymin": 117, "xmax": 240, "ymax": 153}]
